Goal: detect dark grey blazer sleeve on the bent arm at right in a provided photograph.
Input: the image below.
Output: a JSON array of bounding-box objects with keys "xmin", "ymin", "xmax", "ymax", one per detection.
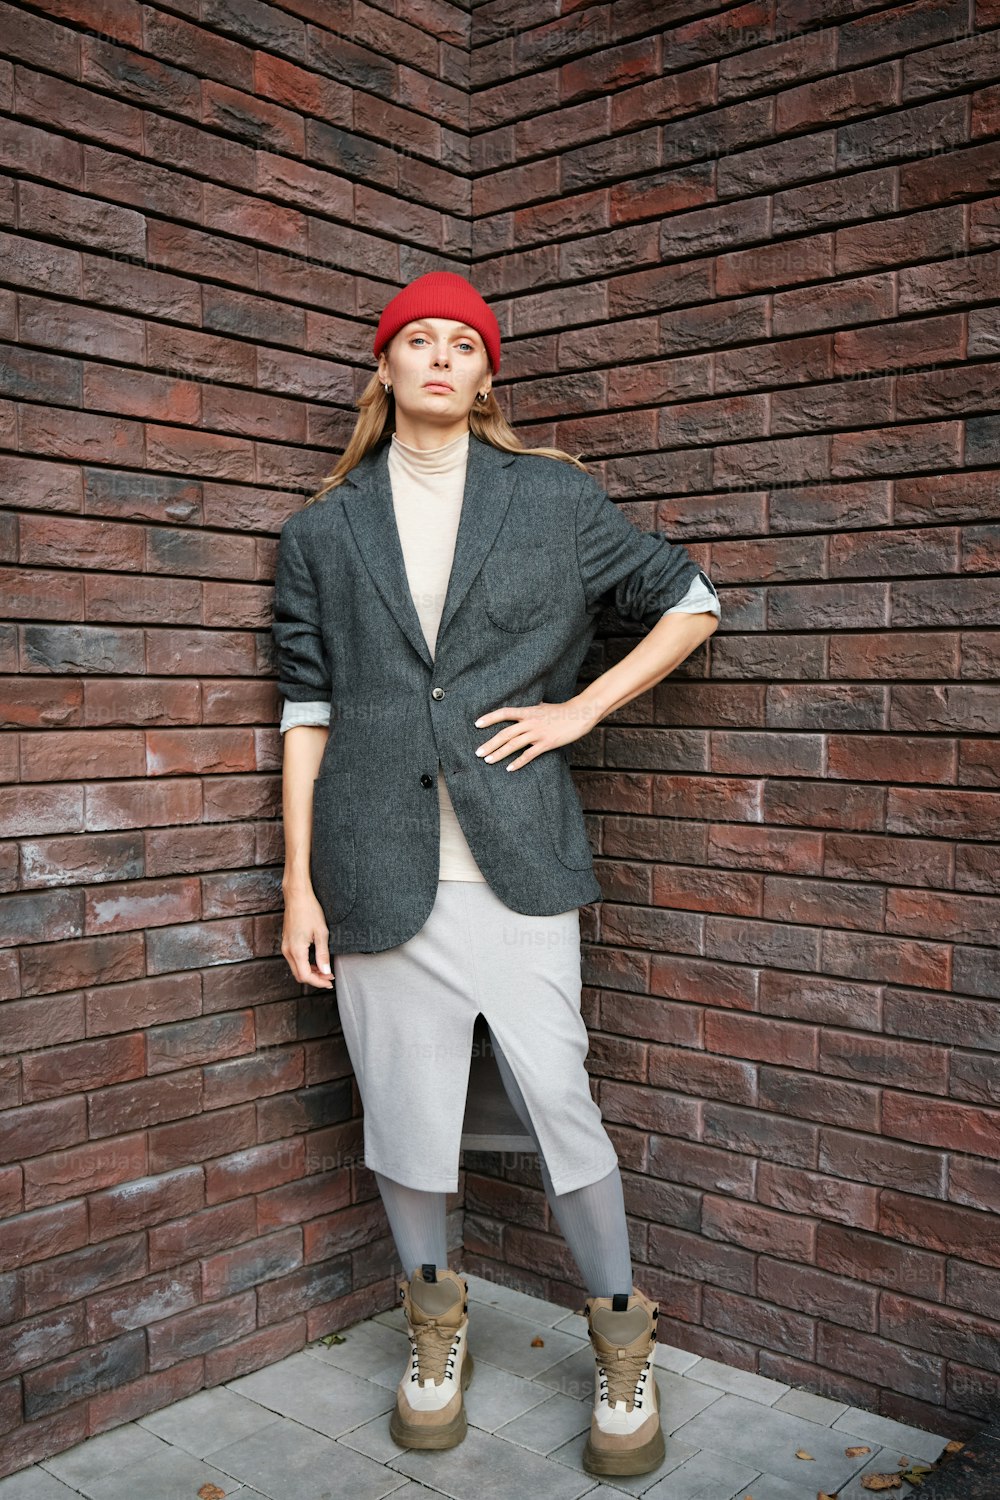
[{"xmin": 576, "ymin": 474, "xmax": 712, "ymax": 629}]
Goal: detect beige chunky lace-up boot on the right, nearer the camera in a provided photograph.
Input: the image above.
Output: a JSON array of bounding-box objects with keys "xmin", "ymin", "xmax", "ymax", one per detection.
[{"xmin": 582, "ymin": 1284, "xmax": 666, "ymax": 1475}]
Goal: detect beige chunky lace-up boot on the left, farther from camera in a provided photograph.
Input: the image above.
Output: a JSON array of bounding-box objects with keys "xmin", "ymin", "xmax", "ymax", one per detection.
[{"xmin": 388, "ymin": 1262, "xmax": 472, "ymax": 1448}]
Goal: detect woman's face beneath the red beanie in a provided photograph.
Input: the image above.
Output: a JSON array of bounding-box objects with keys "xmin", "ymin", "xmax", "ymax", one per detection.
[{"xmin": 378, "ymin": 318, "xmax": 490, "ymax": 426}]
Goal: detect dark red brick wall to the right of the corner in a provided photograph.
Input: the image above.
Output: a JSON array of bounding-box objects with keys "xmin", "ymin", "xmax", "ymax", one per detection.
[{"xmin": 465, "ymin": 0, "xmax": 1000, "ymax": 1452}]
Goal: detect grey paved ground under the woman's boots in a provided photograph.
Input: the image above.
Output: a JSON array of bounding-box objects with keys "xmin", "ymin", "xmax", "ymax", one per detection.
[{"xmin": 0, "ymin": 1275, "xmax": 948, "ymax": 1500}]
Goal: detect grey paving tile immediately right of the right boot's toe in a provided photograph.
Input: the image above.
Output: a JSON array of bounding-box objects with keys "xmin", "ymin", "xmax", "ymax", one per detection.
[{"xmin": 676, "ymin": 1377, "xmax": 881, "ymax": 1494}]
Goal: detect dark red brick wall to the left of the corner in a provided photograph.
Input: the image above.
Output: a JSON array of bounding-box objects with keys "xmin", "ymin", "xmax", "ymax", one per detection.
[{"xmin": 0, "ymin": 0, "xmax": 472, "ymax": 1473}]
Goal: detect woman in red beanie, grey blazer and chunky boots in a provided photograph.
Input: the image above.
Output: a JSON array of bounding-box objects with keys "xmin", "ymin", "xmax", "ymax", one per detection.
[{"xmin": 274, "ymin": 272, "xmax": 720, "ymax": 1475}]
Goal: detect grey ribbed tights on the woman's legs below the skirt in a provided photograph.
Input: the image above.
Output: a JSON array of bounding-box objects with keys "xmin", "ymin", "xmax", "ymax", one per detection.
[{"xmin": 373, "ymin": 1025, "xmax": 633, "ymax": 1298}]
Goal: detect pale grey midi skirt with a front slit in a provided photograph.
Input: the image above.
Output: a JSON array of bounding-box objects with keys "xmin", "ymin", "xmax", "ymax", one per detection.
[{"xmin": 333, "ymin": 881, "xmax": 618, "ymax": 1194}]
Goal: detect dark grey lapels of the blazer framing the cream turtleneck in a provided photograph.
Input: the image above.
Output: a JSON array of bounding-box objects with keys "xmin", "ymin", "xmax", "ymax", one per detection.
[{"xmin": 340, "ymin": 432, "xmax": 514, "ymax": 666}]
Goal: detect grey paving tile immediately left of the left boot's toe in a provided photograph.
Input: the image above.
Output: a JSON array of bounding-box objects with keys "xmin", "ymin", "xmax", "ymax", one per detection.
[{"xmin": 226, "ymin": 1353, "xmax": 399, "ymax": 1437}]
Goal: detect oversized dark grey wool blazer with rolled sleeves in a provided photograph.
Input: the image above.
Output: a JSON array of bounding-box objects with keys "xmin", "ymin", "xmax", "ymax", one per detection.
[{"xmin": 271, "ymin": 434, "xmax": 715, "ymax": 953}]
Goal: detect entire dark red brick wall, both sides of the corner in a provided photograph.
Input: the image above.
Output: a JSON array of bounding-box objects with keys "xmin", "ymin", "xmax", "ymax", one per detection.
[{"xmin": 0, "ymin": 0, "xmax": 1000, "ymax": 1473}]
